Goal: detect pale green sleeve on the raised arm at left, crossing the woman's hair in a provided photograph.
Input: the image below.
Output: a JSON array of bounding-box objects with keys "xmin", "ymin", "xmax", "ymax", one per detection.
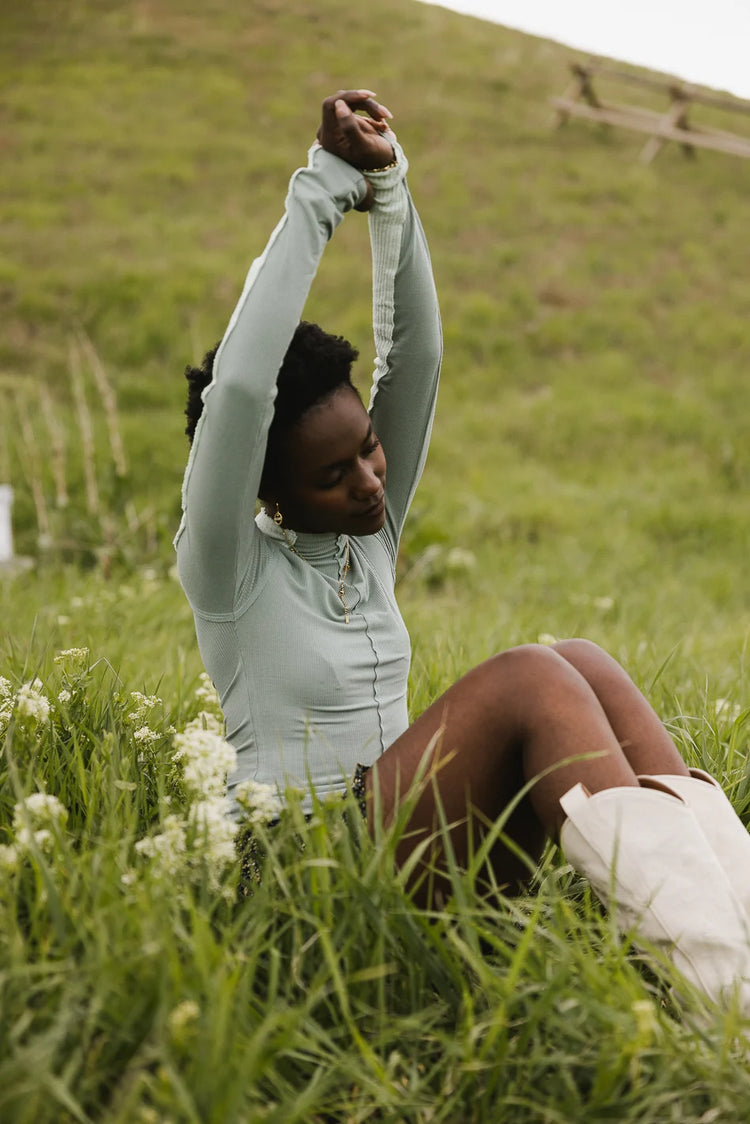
[{"xmin": 175, "ymin": 146, "xmax": 365, "ymax": 615}]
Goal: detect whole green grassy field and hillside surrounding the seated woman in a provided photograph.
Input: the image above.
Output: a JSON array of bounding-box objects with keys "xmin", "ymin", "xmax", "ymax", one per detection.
[{"xmin": 0, "ymin": 0, "xmax": 750, "ymax": 1124}]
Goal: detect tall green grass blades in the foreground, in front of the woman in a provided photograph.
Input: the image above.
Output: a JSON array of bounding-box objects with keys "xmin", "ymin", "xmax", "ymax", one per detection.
[{"xmin": 0, "ymin": 653, "xmax": 750, "ymax": 1124}]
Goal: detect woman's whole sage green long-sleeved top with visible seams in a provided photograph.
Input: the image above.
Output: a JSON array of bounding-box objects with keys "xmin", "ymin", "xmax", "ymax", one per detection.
[{"xmin": 175, "ymin": 145, "xmax": 441, "ymax": 807}]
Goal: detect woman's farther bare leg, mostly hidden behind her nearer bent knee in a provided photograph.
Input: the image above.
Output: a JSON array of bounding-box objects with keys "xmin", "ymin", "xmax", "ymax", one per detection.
[{"xmin": 552, "ymin": 640, "xmax": 688, "ymax": 777}]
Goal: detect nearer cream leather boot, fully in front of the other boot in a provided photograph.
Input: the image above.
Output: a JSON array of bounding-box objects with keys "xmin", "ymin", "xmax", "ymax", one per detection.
[{"xmin": 560, "ymin": 779, "xmax": 750, "ymax": 1016}]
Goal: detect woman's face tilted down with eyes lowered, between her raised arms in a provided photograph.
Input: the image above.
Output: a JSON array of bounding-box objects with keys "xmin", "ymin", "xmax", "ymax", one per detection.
[{"xmin": 271, "ymin": 387, "xmax": 386, "ymax": 535}]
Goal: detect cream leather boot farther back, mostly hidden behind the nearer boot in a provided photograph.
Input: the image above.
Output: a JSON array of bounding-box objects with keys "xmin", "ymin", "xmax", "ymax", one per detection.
[{"xmin": 653, "ymin": 769, "xmax": 750, "ymax": 923}]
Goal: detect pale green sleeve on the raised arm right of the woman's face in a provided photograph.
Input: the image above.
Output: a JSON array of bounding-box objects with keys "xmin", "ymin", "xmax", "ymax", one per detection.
[{"xmin": 370, "ymin": 146, "xmax": 442, "ymax": 553}]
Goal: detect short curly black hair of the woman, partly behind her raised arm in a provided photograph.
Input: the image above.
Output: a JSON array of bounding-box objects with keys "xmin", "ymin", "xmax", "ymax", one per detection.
[{"xmin": 184, "ymin": 320, "xmax": 359, "ymax": 499}]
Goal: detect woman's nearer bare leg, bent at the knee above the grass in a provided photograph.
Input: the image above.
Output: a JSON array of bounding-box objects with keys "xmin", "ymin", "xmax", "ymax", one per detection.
[{"xmin": 368, "ymin": 644, "xmax": 653, "ymax": 899}]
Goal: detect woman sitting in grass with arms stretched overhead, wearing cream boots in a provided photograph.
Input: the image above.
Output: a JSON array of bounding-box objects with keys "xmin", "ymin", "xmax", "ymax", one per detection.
[{"xmin": 177, "ymin": 90, "xmax": 750, "ymax": 1010}]
